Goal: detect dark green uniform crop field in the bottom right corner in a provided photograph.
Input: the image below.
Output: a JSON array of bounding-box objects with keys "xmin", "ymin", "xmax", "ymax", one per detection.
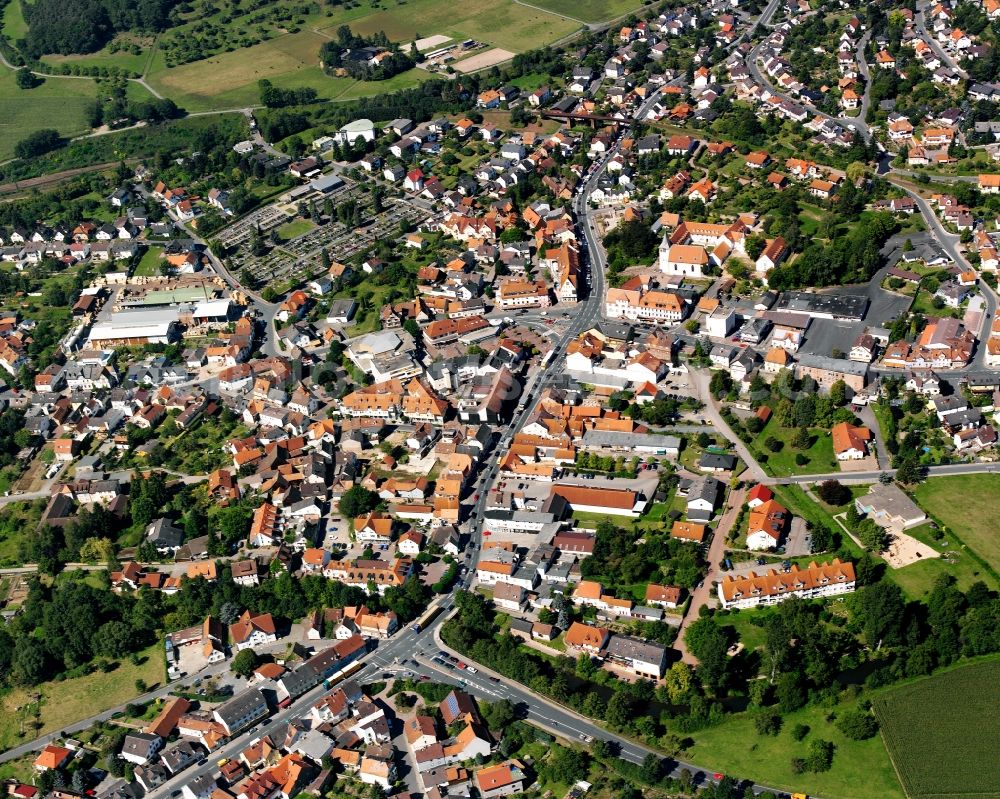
[{"xmin": 875, "ymin": 659, "xmax": 1000, "ymax": 799}]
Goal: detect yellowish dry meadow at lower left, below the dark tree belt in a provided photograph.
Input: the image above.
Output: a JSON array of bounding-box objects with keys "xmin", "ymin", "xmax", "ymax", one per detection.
[{"xmin": 0, "ymin": 643, "xmax": 164, "ymax": 749}]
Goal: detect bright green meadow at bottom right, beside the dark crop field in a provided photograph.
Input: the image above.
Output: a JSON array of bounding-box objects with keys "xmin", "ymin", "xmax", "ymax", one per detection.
[{"xmin": 684, "ymin": 702, "xmax": 908, "ymax": 799}]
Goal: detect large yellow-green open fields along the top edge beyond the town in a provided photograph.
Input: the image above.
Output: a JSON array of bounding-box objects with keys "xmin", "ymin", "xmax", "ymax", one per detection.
[{"xmin": 33, "ymin": 0, "xmax": 584, "ymax": 112}]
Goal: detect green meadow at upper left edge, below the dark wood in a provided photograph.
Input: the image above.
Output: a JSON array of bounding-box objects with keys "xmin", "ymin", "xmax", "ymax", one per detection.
[{"xmin": 0, "ymin": 71, "xmax": 97, "ymax": 160}]
